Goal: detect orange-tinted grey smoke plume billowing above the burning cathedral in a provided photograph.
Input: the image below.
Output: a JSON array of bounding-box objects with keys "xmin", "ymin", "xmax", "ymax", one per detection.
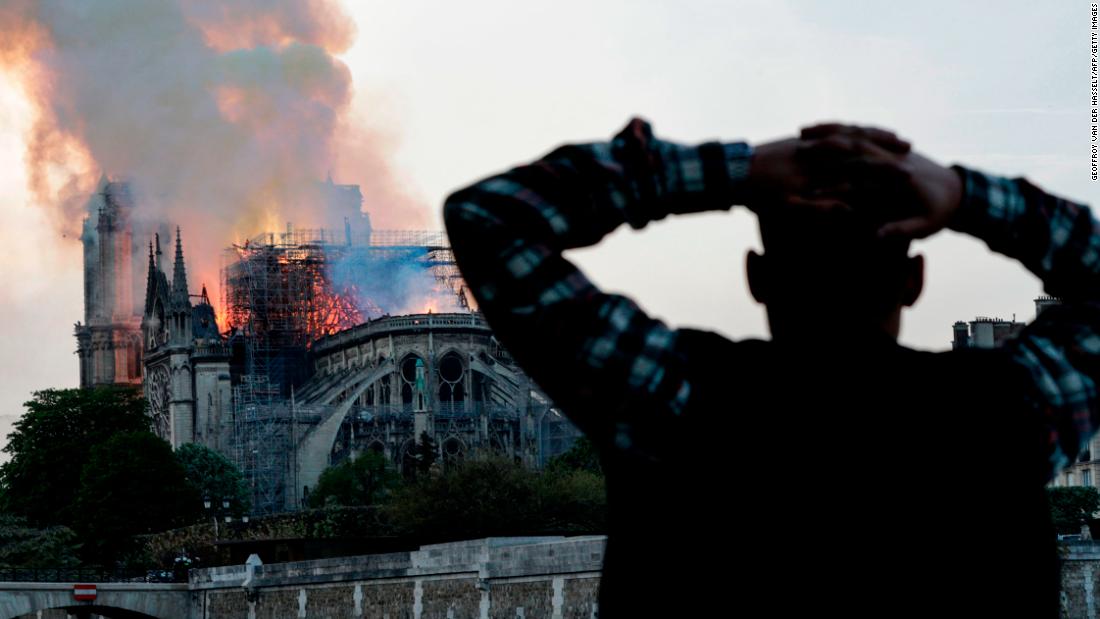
[{"xmin": 0, "ymin": 0, "xmax": 416, "ymax": 307}]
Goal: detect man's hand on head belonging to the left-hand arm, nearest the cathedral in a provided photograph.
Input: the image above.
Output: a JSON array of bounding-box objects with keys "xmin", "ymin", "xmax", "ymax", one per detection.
[{"xmin": 745, "ymin": 124, "xmax": 910, "ymax": 214}]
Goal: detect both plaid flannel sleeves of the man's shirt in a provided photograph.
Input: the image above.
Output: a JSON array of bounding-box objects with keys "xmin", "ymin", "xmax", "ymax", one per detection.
[{"xmin": 444, "ymin": 120, "xmax": 1100, "ymax": 475}]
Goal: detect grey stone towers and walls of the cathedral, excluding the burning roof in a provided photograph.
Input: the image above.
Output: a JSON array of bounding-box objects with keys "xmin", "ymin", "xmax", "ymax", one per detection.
[{"xmin": 76, "ymin": 182, "xmax": 578, "ymax": 513}]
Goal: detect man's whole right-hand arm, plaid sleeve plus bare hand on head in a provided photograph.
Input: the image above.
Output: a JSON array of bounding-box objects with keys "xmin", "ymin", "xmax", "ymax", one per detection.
[{"xmin": 802, "ymin": 124, "xmax": 1100, "ymax": 478}]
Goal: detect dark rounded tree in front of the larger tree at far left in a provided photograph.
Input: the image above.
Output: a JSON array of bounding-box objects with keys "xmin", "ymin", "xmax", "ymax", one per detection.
[{"xmin": 75, "ymin": 432, "xmax": 202, "ymax": 566}]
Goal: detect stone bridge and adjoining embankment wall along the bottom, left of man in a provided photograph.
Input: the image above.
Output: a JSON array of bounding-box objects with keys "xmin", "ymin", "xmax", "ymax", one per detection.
[{"xmin": 0, "ymin": 535, "xmax": 604, "ymax": 619}]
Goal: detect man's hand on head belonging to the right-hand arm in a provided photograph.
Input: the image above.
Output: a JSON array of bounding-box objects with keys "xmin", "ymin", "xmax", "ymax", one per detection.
[{"xmin": 801, "ymin": 123, "xmax": 964, "ymax": 239}]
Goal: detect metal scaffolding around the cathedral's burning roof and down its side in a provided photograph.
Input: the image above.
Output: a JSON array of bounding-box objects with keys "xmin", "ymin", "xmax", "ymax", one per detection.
[{"xmin": 221, "ymin": 225, "xmax": 470, "ymax": 513}]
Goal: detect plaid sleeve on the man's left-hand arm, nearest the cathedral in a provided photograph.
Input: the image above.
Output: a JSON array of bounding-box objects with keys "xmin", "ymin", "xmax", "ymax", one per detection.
[{"xmin": 443, "ymin": 120, "xmax": 751, "ymax": 447}]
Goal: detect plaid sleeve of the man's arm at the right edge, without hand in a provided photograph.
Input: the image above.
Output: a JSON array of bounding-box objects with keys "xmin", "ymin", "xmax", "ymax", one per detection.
[{"xmin": 952, "ymin": 166, "xmax": 1100, "ymax": 476}]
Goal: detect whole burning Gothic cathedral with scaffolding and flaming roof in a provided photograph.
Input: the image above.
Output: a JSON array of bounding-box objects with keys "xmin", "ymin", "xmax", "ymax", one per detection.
[{"xmin": 76, "ymin": 177, "xmax": 576, "ymax": 513}]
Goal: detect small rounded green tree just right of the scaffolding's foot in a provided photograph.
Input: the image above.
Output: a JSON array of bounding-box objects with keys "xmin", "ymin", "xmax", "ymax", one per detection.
[{"xmin": 309, "ymin": 451, "xmax": 398, "ymax": 507}]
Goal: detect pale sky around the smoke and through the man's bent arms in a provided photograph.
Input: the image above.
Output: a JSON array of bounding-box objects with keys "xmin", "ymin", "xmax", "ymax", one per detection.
[{"xmin": 0, "ymin": 0, "xmax": 1100, "ymax": 444}]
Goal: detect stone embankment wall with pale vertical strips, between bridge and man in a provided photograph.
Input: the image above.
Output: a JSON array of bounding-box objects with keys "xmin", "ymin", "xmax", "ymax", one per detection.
[{"xmin": 190, "ymin": 537, "xmax": 604, "ymax": 619}]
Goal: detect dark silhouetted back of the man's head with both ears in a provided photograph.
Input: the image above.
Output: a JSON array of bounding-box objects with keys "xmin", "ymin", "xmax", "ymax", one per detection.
[{"xmin": 747, "ymin": 205, "xmax": 924, "ymax": 341}]
